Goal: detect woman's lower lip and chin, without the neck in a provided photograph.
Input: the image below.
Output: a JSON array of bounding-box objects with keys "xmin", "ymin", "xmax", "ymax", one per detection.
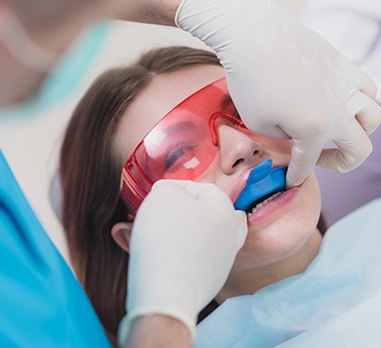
[{"xmin": 224, "ymin": 164, "xmax": 321, "ymax": 273}]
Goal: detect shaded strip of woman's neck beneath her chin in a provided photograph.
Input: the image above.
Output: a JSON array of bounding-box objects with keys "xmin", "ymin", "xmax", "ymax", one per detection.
[{"xmin": 216, "ymin": 229, "xmax": 322, "ymax": 304}]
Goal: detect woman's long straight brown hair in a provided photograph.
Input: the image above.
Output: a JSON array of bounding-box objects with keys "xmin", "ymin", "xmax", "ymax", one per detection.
[{"xmin": 60, "ymin": 47, "xmax": 219, "ymax": 345}]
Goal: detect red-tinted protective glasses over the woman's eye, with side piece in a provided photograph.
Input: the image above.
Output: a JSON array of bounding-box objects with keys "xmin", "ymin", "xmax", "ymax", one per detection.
[{"xmin": 122, "ymin": 79, "xmax": 236, "ymax": 213}]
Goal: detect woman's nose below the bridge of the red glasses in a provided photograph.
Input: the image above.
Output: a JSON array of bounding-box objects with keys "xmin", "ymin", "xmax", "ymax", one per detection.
[{"xmin": 217, "ymin": 124, "xmax": 264, "ymax": 174}]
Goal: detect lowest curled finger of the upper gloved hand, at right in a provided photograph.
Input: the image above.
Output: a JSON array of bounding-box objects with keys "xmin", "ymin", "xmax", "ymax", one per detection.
[{"xmin": 318, "ymin": 120, "xmax": 372, "ymax": 173}]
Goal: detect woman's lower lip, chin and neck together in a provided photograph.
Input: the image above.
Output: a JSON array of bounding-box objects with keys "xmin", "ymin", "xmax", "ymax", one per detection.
[{"xmin": 216, "ymin": 174, "xmax": 322, "ymax": 303}]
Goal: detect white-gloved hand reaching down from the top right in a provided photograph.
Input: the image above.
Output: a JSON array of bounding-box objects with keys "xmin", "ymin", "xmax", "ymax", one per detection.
[{"xmin": 176, "ymin": 0, "xmax": 381, "ymax": 186}]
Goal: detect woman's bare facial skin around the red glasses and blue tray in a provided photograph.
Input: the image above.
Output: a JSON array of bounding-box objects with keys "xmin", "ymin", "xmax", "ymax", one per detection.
[{"xmin": 115, "ymin": 65, "xmax": 320, "ymax": 272}]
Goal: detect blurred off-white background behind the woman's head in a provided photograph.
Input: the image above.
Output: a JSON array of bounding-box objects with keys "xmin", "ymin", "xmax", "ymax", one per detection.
[{"xmin": 0, "ymin": 0, "xmax": 378, "ymax": 266}]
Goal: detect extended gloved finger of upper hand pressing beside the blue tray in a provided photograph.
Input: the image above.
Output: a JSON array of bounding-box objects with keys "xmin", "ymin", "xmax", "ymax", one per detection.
[{"xmin": 286, "ymin": 139, "xmax": 322, "ymax": 188}]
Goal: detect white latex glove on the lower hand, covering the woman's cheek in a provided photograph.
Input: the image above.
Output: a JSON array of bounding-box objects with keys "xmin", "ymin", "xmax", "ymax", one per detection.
[{"xmin": 120, "ymin": 180, "xmax": 247, "ymax": 342}]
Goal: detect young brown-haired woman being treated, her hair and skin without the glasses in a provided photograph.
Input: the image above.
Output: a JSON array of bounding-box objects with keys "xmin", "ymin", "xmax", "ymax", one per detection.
[{"xmin": 60, "ymin": 47, "xmax": 330, "ymax": 343}]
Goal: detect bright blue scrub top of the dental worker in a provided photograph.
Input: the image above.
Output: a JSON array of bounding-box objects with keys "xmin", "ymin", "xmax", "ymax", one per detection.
[{"xmin": 0, "ymin": 151, "xmax": 111, "ymax": 348}]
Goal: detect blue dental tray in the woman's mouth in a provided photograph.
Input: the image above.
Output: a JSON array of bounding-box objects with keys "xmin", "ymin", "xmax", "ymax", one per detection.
[{"xmin": 234, "ymin": 159, "xmax": 286, "ymax": 210}]
